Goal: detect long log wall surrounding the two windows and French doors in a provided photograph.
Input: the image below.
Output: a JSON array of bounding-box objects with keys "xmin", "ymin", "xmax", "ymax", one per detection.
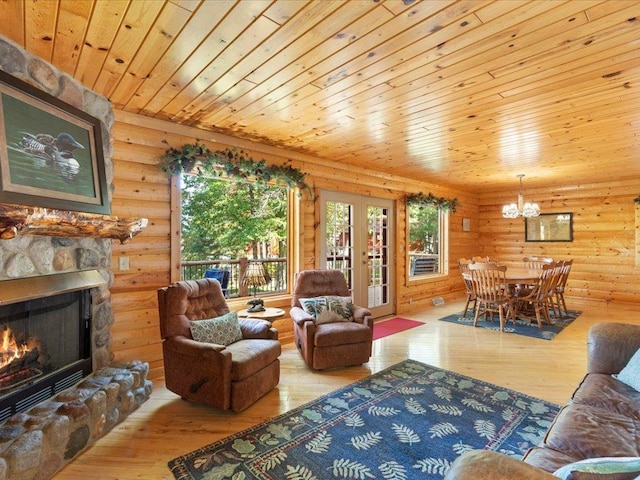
[{"xmin": 111, "ymin": 110, "xmax": 478, "ymax": 379}]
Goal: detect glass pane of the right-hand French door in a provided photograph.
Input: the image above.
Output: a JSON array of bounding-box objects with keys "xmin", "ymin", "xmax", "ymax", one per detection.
[{"xmin": 367, "ymin": 206, "xmax": 390, "ymax": 308}]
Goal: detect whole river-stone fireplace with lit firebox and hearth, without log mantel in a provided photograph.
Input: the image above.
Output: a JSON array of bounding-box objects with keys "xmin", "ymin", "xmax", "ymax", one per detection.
[{"xmin": 0, "ymin": 36, "xmax": 152, "ymax": 480}]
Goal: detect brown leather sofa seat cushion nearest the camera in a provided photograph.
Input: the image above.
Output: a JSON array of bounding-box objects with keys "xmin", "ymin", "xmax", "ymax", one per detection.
[{"xmin": 544, "ymin": 404, "xmax": 640, "ymax": 460}]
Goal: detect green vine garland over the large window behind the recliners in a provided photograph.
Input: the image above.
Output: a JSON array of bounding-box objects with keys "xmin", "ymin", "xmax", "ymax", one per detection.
[{"xmin": 160, "ymin": 142, "xmax": 311, "ymax": 193}]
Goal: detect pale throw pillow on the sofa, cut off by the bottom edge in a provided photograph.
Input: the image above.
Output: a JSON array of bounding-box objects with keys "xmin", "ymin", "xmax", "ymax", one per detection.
[{"xmin": 553, "ymin": 457, "xmax": 640, "ymax": 480}]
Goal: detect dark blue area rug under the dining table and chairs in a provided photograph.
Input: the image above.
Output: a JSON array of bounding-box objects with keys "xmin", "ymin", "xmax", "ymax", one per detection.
[{"xmin": 440, "ymin": 310, "xmax": 582, "ymax": 340}]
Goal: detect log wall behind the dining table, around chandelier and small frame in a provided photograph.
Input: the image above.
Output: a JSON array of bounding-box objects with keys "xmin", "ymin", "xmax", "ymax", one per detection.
[{"xmin": 479, "ymin": 182, "xmax": 640, "ymax": 308}]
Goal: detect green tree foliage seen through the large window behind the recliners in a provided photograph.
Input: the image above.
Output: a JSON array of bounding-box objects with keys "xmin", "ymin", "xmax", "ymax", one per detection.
[{"xmin": 182, "ymin": 175, "xmax": 287, "ymax": 261}]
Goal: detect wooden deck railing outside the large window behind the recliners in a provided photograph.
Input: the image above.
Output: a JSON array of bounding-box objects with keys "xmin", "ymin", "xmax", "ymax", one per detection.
[{"xmin": 181, "ymin": 257, "xmax": 287, "ymax": 298}]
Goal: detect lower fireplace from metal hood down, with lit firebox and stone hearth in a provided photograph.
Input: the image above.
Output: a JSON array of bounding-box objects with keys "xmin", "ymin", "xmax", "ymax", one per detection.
[{"xmin": 0, "ymin": 270, "xmax": 153, "ymax": 480}]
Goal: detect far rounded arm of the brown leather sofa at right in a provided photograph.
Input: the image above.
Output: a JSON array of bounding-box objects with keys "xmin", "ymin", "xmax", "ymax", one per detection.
[{"xmin": 587, "ymin": 323, "xmax": 640, "ymax": 375}]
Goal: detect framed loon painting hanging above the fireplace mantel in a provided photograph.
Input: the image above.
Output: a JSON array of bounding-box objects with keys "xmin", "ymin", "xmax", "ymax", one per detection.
[{"xmin": 0, "ymin": 71, "xmax": 110, "ymax": 215}]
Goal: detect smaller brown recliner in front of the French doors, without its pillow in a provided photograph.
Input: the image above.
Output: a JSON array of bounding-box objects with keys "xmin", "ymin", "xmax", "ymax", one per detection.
[{"xmin": 290, "ymin": 270, "xmax": 373, "ymax": 370}]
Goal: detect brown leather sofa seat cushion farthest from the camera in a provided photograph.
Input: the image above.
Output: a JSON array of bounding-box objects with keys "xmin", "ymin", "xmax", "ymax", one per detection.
[{"xmin": 571, "ymin": 373, "xmax": 640, "ymax": 420}]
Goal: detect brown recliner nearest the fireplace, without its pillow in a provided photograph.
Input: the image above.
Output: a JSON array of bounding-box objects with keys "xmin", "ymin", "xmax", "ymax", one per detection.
[{"xmin": 158, "ymin": 278, "xmax": 282, "ymax": 412}]
